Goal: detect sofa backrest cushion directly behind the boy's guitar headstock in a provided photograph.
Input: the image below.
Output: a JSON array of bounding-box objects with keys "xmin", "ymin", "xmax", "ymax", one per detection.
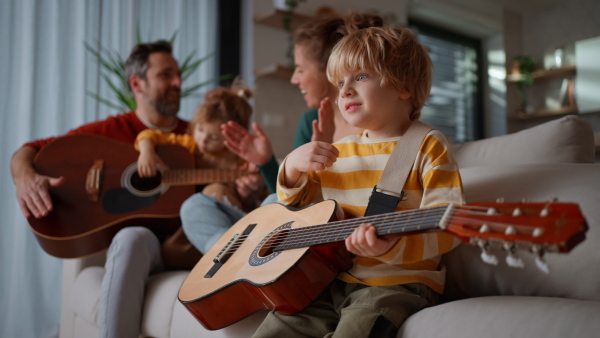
[{"xmin": 442, "ymin": 163, "xmax": 600, "ymax": 301}]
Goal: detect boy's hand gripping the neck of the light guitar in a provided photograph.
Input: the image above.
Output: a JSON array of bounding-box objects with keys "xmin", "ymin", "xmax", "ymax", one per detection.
[{"xmin": 346, "ymin": 224, "xmax": 400, "ymax": 257}]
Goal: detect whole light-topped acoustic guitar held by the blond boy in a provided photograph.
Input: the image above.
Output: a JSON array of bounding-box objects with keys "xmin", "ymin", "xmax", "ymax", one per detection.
[{"xmin": 178, "ymin": 200, "xmax": 587, "ymax": 330}]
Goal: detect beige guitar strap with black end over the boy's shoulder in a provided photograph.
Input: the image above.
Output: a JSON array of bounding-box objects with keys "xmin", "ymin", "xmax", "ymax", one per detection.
[{"xmin": 365, "ymin": 121, "xmax": 433, "ymax": 216}]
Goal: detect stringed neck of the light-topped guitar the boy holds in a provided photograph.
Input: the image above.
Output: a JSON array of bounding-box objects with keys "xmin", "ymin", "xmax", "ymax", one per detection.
[{"xmin": 273, "ymin": 205, "xmax": 454, "ymax": 251}]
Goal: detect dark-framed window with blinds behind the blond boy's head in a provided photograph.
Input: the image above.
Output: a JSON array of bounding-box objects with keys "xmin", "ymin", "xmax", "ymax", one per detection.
[{"xmin": 409, "ymin": 20, "xmax": 483, "ymax": 143}]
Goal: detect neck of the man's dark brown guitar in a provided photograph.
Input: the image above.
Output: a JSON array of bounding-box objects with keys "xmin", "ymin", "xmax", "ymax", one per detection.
[{"xmin": 162, "ymin": 169, "xmax": 250, "ymax": 186}]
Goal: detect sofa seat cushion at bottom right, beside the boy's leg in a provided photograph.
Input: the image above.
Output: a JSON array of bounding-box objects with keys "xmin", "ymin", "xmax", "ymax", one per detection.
[{"xmin": 398, "ymin": 296, "xmax": 600, "ymax": 338}]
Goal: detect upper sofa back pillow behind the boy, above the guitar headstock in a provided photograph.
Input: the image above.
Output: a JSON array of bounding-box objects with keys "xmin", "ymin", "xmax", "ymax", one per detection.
[{"xmin": 453, "ymin": 115, "xmax": 596, "ymax": 168}]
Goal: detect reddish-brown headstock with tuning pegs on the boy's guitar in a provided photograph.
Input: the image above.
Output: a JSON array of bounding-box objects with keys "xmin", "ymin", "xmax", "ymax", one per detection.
[{"xmin": 446, "ymin": 201, "xmax": 588, "ymax": 272}]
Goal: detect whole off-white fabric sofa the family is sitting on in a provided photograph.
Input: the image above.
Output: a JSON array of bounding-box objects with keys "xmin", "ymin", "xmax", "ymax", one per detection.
[{"xmin": 60, "ymin": 116, "xmax": 600, "ymax": 338}]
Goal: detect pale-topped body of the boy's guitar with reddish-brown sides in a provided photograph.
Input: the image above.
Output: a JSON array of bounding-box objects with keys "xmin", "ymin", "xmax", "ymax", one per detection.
[{"xmin": 178, "ymin": 200, "xmax": 352, "ymax": 330}]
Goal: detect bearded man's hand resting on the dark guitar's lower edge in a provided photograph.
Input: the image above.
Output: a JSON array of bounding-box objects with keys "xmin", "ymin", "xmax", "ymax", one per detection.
[{"xmin": 15, "ymin": 171, "xmax": 65, "ymax": 218}]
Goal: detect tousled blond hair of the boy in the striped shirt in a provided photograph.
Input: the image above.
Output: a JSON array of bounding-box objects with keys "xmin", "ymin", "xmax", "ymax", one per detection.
[{"xmin": 327, "ymin": 26, "xmax": 433, "ymax": 121}]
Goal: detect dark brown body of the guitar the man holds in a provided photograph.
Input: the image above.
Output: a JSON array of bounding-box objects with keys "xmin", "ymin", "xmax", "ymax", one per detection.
[{"xmin": 28, "ymin": 134, "xmax": 195, "ymax": 258}]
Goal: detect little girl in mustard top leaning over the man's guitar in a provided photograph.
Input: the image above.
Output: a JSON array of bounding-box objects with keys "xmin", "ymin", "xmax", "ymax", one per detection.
[{"xmin": 135, "ymin": 81, "xmax": 258, "ymax": 211}]
